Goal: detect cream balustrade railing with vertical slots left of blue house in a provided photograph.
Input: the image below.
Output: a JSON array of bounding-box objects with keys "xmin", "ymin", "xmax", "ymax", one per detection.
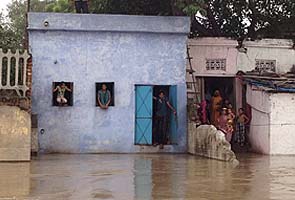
[{"xmin": 0, "ymin": 49, "xmax": 30, "ymax": 97}]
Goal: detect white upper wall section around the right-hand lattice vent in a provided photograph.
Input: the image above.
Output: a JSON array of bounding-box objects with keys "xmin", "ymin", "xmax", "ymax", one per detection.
[{"xmin": 237, "ymin": 39, "xmax": 295, "ymax": 73}]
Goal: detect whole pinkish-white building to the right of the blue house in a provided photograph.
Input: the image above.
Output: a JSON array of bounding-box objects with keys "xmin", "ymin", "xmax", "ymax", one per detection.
[{"xmin": 187, "ymin": 38, "xmax": 295, "ymax": 154}]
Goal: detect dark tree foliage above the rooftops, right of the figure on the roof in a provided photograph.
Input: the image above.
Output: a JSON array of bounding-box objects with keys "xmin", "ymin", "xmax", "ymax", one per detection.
[{"xmin": 85, "ymin": 0, "xmax": 295, "ymax": 39}]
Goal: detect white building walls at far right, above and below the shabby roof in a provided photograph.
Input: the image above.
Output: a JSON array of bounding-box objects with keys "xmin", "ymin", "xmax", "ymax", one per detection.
[{"xmin": 237, "ymin": 39, "xmax": 295, "ymax": 154}]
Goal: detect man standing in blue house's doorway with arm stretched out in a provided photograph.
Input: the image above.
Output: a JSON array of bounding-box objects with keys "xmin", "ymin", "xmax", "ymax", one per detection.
[{"xmin": 153, "ymin": 91, "xmax": 177, "ymax": 149}]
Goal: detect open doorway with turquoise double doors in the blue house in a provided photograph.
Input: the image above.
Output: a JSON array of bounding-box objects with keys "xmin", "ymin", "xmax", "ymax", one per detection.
[{"xmin": 135, "ymin": 85, "xmax": 177, "ymax": 145}]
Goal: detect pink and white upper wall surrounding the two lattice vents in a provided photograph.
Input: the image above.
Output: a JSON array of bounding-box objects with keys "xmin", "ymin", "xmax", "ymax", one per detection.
[{"xmin": 188, "ymin": 37, "xmax": 295, "ymax": 76}]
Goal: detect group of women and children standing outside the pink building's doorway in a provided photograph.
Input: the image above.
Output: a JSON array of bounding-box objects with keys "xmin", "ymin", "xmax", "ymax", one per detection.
[{"xmin": 199, "ymin": 90, "xmax": 250, "ymax": 146}]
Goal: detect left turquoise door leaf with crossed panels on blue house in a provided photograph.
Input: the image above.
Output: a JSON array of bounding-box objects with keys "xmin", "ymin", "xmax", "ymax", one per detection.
[{"xmin": 135, "ymin": 86, "xmax": 153, "ymax": 145}]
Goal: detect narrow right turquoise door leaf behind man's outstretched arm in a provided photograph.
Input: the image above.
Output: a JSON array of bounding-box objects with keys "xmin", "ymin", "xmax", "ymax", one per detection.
[{"xmin": 169, "ymin": 85, "xmax": 178, "ymax": 144}]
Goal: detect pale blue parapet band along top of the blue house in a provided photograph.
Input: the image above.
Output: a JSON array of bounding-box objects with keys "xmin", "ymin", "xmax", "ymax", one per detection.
[{"xmin": 28, "ymin": 12, "xmax": 190, "ymax": 34}]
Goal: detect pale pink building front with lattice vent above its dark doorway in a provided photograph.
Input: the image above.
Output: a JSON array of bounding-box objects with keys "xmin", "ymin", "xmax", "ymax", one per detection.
[{"xmin": 187, "ymin": 38, "xmax": 238, "ymax": 108}]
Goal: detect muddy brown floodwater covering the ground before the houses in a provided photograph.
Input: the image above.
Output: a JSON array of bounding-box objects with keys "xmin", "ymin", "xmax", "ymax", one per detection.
[{"xmin": 0, "ymin": 154, "xmax": 295, "ymax": 200}]
